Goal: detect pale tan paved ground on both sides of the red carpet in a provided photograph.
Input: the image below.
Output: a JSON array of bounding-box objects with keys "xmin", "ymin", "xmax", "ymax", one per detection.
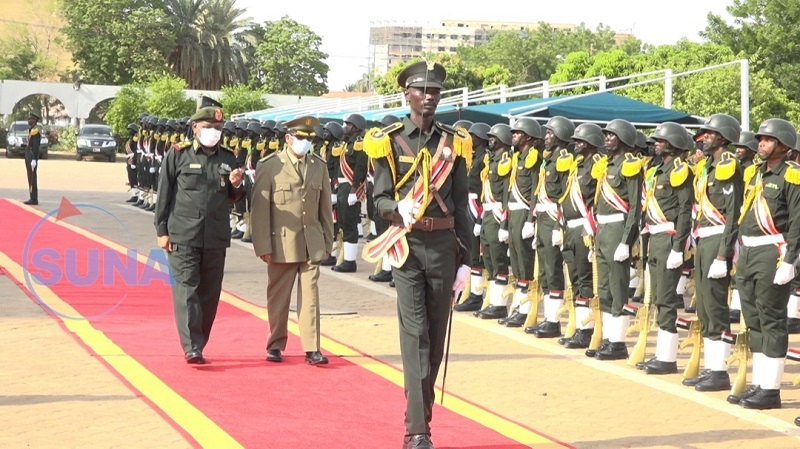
[{"xmin": 0, "ymin": 153, "xmax": 800, "ymax": 449}]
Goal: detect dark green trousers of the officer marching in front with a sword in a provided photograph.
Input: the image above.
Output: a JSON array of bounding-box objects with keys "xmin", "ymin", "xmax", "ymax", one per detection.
[{"xmin": 392, "ymin": 230, "xmax": 459, "ymax": 435}]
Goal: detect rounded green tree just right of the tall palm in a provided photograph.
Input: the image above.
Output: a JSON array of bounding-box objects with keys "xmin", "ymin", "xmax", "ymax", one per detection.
[{"xmin": 254, "ymin": 16, "xmax": 329, "ymax": 95}]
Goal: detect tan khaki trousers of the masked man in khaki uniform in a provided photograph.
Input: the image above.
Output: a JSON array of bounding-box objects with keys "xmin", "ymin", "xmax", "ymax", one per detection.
[{"xmin": 267, "ymin": 262, "xmax": 320, "ymax": 352}]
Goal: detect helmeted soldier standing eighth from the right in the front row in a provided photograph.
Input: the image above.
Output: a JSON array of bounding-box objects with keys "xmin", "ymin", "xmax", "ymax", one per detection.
[{"xmin": 475, "ymin": 123, "xmax": 513, "ymax": 320}]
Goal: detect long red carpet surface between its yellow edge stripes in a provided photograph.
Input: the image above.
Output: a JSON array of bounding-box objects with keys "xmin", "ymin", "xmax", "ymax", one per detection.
[{"xmin": 0, "ymin": 200, "xmax": 552, "ymax": 449}]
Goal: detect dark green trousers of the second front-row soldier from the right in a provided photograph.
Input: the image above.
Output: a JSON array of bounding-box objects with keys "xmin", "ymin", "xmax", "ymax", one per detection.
[{"xmin": 694, "ymin": 235, "xmax": 732, "ymax": 340}]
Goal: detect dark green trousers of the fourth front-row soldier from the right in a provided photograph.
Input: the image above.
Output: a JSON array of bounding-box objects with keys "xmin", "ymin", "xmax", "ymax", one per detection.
[{"xmin": 595, "ymin": 221, "xmax": 631, "ymax": 317}]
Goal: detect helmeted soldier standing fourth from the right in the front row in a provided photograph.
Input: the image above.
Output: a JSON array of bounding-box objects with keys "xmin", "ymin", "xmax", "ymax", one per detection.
[{"xmin": 586, "ymin": 119, "xmax": 645, "ymax": 360}]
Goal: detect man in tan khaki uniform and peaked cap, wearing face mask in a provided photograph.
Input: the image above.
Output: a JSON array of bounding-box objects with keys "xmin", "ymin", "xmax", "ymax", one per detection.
[{"xmin": 252, "ymin": 117, "xmax": 333, "ymax": 365}]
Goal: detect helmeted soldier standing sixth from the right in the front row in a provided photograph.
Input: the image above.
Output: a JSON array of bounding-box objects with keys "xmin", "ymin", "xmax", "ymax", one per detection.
[{"xmin": 525, "ymin": 116, "xmax": 575, "ymax": 338}]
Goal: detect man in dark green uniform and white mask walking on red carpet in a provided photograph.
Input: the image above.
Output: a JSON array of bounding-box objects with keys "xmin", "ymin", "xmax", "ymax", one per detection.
[{"xmin": 155, "ymin": 100, "xmax": 245, "ymax": 363}]
